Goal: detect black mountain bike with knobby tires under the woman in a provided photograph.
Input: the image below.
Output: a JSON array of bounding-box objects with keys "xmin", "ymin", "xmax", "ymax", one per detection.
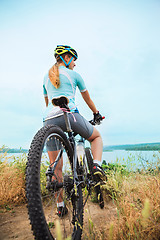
[{"xmin": 26, "ymin": 97, "xmax": 104, "ymax": 240}]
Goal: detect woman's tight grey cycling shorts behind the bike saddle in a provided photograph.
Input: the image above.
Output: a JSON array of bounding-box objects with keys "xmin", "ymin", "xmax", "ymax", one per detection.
[{"xmin": 44, "ymin": 113, "xmax": 93, "ymax": 151}]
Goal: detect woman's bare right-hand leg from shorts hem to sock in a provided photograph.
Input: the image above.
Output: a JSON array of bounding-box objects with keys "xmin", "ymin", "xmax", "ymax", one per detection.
[{"xmin": 87, "ymin": 127, "xmax": 103, "ymax": 162}]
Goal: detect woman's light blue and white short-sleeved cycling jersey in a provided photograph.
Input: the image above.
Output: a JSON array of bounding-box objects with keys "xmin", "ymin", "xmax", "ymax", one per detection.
[{"xmin": 43, "ymin": 66, "xmax": 86, "ymax": 120}]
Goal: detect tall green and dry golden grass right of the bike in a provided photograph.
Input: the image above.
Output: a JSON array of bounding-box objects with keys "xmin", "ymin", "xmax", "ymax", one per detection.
[{"xmin": 100, "ymin": 151, "xmax": 160, "ymax": 240}]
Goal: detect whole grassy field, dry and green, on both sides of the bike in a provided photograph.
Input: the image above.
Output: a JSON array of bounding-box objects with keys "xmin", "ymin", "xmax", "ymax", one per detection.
[{"xmin": 0, "ymin": 147, "xmax": 160, "ymax": 240}]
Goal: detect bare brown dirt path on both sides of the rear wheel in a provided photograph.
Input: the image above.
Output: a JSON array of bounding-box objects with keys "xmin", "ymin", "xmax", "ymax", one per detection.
[{"xmin": 0, "ymin": 201, "xmax": 116, "ymax": 240}]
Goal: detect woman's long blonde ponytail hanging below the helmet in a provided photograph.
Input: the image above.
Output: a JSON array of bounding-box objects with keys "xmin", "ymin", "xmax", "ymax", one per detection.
[{"xmin": 49, "ymin": 63, "xmax": 60, "ymax": 89}]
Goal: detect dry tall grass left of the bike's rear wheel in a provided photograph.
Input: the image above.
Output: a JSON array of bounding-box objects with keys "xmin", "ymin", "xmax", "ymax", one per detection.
[{"xmin": 0, "ymin": 149, "xmax": 27, "ymax": 206}]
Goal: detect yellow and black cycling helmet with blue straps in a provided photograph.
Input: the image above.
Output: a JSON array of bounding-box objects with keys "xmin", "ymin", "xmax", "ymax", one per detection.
[{"xmin": 54, "ymin": 45, "xmax": 78, "ymax": 67}]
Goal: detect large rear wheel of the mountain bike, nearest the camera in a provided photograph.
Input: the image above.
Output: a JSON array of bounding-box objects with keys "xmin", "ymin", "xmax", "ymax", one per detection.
[{"xmin": 26, "ymin": 125, "xmax": 83, "ymax": 240}]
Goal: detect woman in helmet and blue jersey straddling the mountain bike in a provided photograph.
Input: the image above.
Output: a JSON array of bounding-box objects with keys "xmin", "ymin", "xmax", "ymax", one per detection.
[{"xmin": 43, "ymin": 45, "xmax": 104, "ymax": 216}]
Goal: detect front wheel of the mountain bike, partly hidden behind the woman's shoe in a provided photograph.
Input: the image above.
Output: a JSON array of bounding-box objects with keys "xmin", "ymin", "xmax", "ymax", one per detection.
[{"xmin": 85, "ymin": 148, "xmax": 104, "ymax": 208}]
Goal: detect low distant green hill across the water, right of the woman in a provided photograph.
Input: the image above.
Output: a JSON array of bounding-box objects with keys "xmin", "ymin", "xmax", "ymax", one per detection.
[{"xmin": 103, "ymin": 143, "xmax": 160, "ymax": 151}]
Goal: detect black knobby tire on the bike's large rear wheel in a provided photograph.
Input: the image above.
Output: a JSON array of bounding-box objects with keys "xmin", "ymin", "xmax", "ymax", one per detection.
[{"xmin": 26, "ymin": 125, "xmax": 83, "ymax": 240}]
